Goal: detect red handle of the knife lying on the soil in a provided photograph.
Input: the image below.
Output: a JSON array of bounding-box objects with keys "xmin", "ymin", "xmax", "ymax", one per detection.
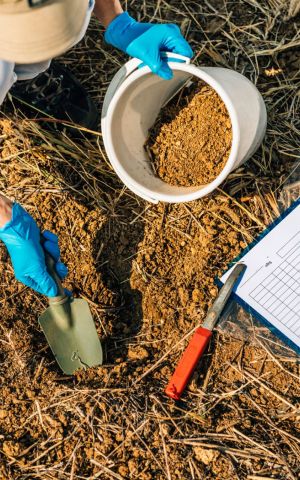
[{"xmin": 165, "ymin": 327, "xmax": 212, "ymax": 400}]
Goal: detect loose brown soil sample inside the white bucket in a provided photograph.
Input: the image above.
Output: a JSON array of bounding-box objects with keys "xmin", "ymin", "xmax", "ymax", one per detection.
[{"xmin": 145, "ymin": 81, "xmax": 232, "ymax": 187}]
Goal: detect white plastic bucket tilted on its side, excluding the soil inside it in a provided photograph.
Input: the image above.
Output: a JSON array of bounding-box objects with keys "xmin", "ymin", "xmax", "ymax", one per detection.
[{"xmin": 102, "ymin": 54, "xmax": 267, "ymax": 203}]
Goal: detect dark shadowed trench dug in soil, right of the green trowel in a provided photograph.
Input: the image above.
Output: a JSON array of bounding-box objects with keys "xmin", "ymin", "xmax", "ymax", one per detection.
[{"xmin": 93, "ymin": 204, "xmax": 144, "ymax": 363}]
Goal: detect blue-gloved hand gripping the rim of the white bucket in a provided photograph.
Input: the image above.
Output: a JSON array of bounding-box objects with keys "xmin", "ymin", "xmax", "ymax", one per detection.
[{"xmin": 104, "ymin": 12, "xmax": 193, "ymax": 80}]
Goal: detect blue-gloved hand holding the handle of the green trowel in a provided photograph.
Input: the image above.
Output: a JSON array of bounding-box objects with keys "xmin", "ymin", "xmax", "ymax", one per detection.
[{"xmin": 0, "ymin": 203, "xmax": 68, "ymax": 297}]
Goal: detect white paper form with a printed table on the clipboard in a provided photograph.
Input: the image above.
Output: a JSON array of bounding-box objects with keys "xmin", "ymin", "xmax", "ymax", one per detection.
[{"xmin": 221, "ymin": 202, "xmax": 300, "ymax": 348}]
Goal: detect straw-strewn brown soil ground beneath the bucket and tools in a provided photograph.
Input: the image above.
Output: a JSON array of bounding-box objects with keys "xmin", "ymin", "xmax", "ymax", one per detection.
[{"xmin": 0, "ymin": 1, "xmax": 300, "ymax": 480}]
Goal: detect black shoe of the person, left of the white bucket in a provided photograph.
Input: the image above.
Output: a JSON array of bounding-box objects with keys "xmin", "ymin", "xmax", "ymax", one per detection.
[{"xmin": 10, "ymin": 62, "xmax": 99, "ymax": 130}]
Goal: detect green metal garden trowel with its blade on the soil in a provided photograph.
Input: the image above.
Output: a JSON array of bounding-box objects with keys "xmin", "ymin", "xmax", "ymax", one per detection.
[{"xmin": 39, "ymin": 253, "xmax": 103, "ymax": 375}]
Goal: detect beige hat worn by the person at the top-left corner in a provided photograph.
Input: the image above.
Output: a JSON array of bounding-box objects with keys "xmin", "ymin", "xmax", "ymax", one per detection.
[{"xmin": 0, "ymin": 0, "xmax": 89, "ymax": 63}]
